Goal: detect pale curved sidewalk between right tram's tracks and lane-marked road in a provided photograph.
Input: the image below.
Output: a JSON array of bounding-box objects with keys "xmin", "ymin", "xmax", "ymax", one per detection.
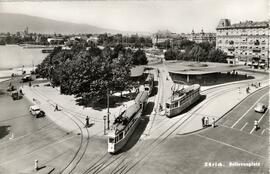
[{"xmin": 178, "ymin": 81, "xmax": 269, "ymax": 135}]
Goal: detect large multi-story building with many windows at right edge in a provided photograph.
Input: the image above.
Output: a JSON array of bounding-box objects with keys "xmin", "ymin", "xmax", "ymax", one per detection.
[{"xmin": 216, "ymin": 19, "xmax": 269, "ymax": 68}]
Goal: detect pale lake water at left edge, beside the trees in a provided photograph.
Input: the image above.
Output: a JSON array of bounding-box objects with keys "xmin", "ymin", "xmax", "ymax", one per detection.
[{"xmin": 0, "ymin": 45, "xmax": 48, "ymax": 69}]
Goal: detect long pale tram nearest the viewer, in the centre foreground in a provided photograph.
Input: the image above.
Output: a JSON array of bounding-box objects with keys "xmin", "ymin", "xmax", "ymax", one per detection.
[{"xmin": 108, "ymin": 91, "xmax": 148, "ymax": 154}]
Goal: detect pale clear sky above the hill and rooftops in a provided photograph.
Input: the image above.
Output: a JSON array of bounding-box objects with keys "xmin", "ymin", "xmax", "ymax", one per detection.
[{"xmin": 0, "ymin": 0, "xmax": 270, "ymax": 33}]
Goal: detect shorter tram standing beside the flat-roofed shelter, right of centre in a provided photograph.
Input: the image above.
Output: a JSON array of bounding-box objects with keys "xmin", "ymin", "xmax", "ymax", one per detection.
[{"xmin": 165, "ymin": 84, "xmax": 201, "ymax": 117}]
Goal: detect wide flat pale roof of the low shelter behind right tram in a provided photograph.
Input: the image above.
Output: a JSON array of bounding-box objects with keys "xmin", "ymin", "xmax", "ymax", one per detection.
[{"xmin": 167, "ymin": 62, "xmax": 246, "ymax": 75}]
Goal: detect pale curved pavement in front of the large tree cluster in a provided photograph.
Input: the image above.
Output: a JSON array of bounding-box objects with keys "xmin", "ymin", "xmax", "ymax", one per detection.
[{"xmin": 23, "ymin": 84, "xmax": 133, "ymax": 136}]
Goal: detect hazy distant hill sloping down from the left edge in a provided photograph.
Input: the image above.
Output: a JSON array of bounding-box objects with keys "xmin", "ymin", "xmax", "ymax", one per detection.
[{"xmin": 0, "ymin": 13, "xmax": 122, "ymax": 34}]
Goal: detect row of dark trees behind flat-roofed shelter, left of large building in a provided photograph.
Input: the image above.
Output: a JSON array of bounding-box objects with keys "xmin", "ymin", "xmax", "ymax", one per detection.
[{"xmin": 164, "ymin": 40, "xmax": 227, "ymax": 63}]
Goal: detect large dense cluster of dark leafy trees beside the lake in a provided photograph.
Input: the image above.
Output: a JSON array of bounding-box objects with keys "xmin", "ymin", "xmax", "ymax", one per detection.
[{"xmin": 36, "ymin": 43, "xmax": 147, "ymax": 106}]
